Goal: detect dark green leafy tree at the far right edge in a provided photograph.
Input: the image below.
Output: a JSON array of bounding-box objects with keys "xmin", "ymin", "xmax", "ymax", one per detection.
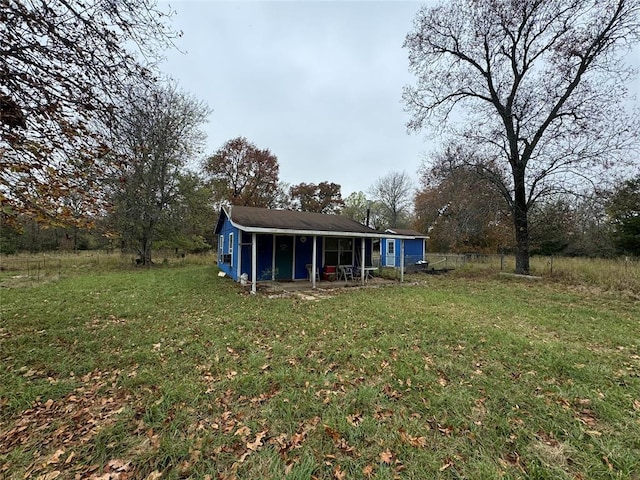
[{"xmin": 607, "ymin": 176, "xmax": 640, "ymax": 256}]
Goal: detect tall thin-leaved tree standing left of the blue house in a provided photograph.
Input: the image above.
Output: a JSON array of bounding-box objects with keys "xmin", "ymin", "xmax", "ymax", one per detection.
[{"xmin": 114, "ymin": 83, "xmax": 209, "ymax": 265}]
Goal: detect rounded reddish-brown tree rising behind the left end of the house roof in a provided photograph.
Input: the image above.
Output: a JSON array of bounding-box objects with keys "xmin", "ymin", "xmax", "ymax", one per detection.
[{"xmin": 203, "ymin": 137, "xmax": 281, "ymax": 207}]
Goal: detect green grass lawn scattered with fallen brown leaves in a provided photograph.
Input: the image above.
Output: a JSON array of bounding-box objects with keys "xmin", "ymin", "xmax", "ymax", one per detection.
[{"xmin": 0, "ymin": 265, "xmax": 640, "ymax": 480}]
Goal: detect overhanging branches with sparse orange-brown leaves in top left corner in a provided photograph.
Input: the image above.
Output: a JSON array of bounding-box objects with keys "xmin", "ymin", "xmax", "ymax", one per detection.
[{"xmin": 0, "ymin": 0, "xmax": 175, "ymax": 223}]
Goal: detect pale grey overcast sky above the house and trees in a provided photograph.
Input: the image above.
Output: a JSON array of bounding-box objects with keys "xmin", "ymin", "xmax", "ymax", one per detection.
[{"xmin": 163, "ymin": 0, "xmax": 640, "ymax": 197}]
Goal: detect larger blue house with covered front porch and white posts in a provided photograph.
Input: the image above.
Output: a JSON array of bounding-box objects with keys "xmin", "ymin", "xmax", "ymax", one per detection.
[{"xmin": 215, "ymin": 206, "xmax": 410, "ymax": 292}]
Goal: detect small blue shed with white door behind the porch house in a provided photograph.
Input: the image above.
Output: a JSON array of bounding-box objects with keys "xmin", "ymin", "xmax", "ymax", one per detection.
[{"xmin": 380, "ymin": 228, "xmax": 428, "ymax": 269}]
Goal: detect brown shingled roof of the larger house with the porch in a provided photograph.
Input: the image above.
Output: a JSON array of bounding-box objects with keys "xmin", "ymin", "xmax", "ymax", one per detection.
[{"xmin": 216, "ymin": 206, "xmax": 416, "ymax": 238}]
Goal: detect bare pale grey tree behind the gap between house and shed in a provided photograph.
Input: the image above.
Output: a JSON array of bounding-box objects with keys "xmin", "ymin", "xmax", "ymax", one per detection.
[{"xmin": 369, "ymin": 172, "xmax": 413, "ymax": 228}]
